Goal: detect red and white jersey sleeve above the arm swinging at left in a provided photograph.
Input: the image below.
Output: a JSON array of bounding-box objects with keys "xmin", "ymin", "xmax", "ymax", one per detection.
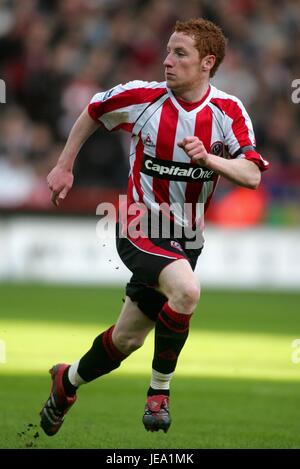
[{"xmin": 88, "ymin": 80, "xmax": 165, "ymax": 132}]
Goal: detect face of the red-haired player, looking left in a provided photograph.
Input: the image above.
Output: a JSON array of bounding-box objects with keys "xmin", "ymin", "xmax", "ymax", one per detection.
[{"xmin": 164, "ymin": 32, "xmax": 207, "ymax": 92}]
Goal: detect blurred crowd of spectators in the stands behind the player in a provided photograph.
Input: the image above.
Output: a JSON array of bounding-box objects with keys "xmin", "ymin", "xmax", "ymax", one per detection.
[{"xmin": 0, "ymin": 0, "xmax": 300, "ymax": 217}]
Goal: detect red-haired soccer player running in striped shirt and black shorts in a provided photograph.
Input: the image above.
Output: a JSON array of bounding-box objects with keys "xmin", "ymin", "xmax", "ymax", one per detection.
[{"xmin": 41, "ymin": 18, "xmax": 268, "ymax": 435}]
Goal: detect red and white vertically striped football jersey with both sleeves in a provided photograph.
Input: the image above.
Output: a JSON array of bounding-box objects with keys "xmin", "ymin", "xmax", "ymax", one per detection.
[{"xmin": 88, "ymin": 81, "xmax": 268, "ymax": 230}]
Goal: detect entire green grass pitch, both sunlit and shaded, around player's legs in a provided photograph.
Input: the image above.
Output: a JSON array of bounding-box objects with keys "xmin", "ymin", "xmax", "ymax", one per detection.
[{"xmin": 0, "ymin": 284, "xmax": 300, "ymax": 449}]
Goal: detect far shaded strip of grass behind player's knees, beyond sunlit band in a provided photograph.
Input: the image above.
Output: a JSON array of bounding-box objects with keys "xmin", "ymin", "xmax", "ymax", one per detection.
[{"xmin": 0, "ymin": 284, "xmax": 300, "ymax": 338}]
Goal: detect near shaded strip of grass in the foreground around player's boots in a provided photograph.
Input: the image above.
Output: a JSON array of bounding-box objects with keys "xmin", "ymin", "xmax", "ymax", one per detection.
[{"xmin": 0, "ymin": 374, "xmax": 300, "ymax": 449}]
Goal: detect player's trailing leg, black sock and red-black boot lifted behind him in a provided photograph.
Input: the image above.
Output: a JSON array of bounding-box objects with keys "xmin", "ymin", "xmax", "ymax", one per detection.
[{"xmin": 40, "ymin": 297, "xmax": 155, "ymax": 436}]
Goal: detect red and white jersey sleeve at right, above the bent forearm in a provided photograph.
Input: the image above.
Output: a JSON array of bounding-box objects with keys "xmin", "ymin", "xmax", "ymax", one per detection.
[{"xmin": 225, "ymin": 98, "xmax": 269, "ymax": 171}]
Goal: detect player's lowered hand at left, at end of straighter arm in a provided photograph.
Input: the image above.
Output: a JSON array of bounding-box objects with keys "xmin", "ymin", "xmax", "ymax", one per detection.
[{"xmin": 47, "ymin": 165, "xmax": 74, "ymax": 207}]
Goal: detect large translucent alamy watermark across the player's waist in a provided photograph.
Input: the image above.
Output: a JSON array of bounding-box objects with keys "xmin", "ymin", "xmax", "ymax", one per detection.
[{"xmin": 96, "ymin": 195, "xmax": 204, "ymax": 249}]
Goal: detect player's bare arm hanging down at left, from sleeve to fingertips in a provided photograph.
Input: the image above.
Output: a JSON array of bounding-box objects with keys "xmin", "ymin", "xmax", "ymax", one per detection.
[{"xmin": 47, "ymin": 108, "xmax": 99, "ymax": 207}]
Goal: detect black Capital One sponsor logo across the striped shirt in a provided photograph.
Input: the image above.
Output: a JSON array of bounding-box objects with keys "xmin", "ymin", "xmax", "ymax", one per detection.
[{"xmin": 141, "ymin": 153, "xmax": 216, "ymax": 182}]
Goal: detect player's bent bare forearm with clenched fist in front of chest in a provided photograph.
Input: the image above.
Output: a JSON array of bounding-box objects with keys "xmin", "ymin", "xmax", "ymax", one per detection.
[{"xmin": 178, "ymin": 136, "xmax": 261, "ymax": 189}]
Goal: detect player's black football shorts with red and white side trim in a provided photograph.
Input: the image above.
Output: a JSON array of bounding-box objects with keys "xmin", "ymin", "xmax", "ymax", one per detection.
[{"xmin": 116, "ymin": 223, "xmax": 202, "ymax": 321}]
